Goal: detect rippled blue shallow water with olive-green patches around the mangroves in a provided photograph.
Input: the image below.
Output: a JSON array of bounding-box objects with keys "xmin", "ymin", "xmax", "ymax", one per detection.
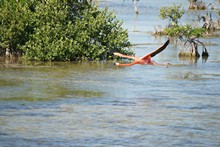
[{"xmin": 0, "ymin": 0, "xmax": 220, "ymax": 146}]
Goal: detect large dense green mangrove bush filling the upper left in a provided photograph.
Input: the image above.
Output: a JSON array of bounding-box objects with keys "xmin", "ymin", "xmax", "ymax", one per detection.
[{"xmin": 0, "ymin": 0, "xmax": 133, "ymax": 61}]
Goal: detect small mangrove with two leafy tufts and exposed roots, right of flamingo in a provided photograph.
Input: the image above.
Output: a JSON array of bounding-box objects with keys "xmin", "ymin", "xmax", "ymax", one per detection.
[{"xmin": 160, "ymin": 5, "xmax": 209, "ymax": 58}]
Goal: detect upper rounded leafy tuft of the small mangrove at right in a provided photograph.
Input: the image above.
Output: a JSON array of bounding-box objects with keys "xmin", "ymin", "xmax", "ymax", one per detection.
[{"xmin": 160, "ymin": 5, "xmax": 184, "ymax": 26}]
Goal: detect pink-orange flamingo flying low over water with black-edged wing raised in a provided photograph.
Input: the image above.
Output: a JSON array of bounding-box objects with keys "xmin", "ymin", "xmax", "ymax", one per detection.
[{"xmin": 114, "ymin": 40, "xmax": 170, "ymax": 67}]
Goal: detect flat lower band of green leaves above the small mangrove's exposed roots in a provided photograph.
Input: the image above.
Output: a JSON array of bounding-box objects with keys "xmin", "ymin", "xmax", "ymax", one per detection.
[{"xmin": 164, "ymin": 25, "xmax": 205, "ymax": 38}]
